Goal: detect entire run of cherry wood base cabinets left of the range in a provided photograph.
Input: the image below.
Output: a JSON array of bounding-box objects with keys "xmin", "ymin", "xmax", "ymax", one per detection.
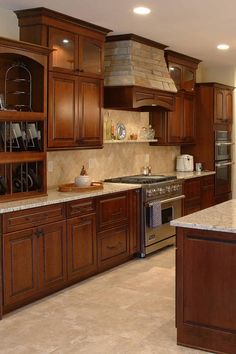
[{"xmin": 0, "ymin": 189, "xmax": 140, "ymax": 319}]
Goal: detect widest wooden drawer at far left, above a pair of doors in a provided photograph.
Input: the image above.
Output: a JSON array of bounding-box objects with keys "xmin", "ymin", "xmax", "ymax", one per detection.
[{"xmin": 3, "ymin": 203, "xmax": 65, "ymax": 233}]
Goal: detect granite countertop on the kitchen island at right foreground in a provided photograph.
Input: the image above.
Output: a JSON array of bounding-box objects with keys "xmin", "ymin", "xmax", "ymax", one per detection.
[{"xmin": 170, "ymin": 199, "xmax": 236, "ymax": 233}]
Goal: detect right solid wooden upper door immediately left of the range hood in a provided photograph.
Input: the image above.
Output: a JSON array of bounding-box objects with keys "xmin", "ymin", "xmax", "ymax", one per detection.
[{"xmin": 79, "ymin": 78, "xmax": 103, "ymax": 146}]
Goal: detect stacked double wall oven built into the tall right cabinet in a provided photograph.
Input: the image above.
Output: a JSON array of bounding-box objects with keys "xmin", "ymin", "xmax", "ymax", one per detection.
[{"xmin": 215, "ymin": 130, "xmax": 233, "ymax": 201}]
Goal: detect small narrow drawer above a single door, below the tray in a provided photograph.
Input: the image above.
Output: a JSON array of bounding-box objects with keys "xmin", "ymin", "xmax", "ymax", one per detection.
[{"xmin": 66, "ymin": 199, "xmax": 96, "ymax": 218}]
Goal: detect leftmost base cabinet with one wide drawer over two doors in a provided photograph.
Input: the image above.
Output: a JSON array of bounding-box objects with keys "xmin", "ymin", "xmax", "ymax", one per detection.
[{"xmin": 2, "ymin": 204, "xmax": 67, "ymax": 312}]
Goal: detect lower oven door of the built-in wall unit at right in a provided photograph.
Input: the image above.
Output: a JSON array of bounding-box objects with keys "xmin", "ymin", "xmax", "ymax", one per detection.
[{"xmin": 215, "ymin": 161, "xmax": 233, "ymax": 195}]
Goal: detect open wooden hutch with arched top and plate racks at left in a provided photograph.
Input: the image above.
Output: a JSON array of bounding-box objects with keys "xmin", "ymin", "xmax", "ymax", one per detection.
[{"xmin": 0, "ymin": 38, "xmax": 50, "ymax": 202}]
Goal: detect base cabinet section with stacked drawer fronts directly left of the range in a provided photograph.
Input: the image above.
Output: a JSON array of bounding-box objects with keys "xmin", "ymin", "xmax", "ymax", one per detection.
[{"xmin": 97, "ymin": 191, "xmax": 136, "ymax": 270}]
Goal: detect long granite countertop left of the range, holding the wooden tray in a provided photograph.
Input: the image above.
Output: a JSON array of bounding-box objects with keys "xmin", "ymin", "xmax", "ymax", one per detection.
[{"xmin": 0, "ymin": 183, "xmax": 141, "ymax": 214}]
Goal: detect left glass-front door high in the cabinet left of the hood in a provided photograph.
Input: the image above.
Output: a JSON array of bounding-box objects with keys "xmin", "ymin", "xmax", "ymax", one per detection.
[{"xmin": 49, "ymin": 28, "xmax": 76, "ymax": 71}]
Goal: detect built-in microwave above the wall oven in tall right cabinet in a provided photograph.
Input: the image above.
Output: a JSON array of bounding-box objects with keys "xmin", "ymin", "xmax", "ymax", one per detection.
[{"xmin": 215, "ymin": 130, "xmax": 233, "ymax": 161}]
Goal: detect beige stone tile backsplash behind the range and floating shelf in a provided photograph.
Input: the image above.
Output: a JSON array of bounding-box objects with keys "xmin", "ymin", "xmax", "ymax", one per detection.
[{"xmin": 47, "ymin": 110, "xmax": 180, "ymax": 188}]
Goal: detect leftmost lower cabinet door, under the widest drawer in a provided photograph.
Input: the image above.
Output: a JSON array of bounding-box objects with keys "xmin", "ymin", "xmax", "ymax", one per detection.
[{"xmin": 3, "ymin": 229, "xmax": 38, "ymax": 305}]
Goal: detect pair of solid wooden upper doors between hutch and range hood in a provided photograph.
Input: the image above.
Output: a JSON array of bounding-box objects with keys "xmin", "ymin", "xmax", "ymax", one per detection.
[{"xmin": 48, "ymin": 72, "xmax": 103, "ymax": 148}]
